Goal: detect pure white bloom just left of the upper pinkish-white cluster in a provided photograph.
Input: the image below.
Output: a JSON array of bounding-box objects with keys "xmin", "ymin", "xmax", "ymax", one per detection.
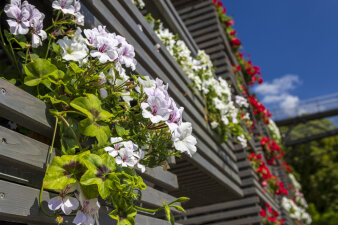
[{"xmin": 57, "ymin": 36, "xmax": 88, "ymax": 62}]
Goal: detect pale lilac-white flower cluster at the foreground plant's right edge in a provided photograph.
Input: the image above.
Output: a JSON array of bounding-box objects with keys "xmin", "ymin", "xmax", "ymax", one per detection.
[{"xmin": 141, "ymin": 78, "xmax": 197, "ymax": 156}]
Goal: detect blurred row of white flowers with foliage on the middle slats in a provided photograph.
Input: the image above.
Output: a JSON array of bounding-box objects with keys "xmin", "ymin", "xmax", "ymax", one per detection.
[{"xmin": 146, "ymin": 15, "xmax": 250, "ymax": 147}]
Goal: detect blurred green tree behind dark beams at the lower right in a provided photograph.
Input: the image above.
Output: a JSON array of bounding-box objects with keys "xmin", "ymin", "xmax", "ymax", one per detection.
[{"xmin": 281, "ymin": 119, "xmax": 338, "ymax": 225}]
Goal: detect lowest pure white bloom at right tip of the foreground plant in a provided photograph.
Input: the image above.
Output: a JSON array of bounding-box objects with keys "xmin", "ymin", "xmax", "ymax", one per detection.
[{"xmin": 172, "ymin": 122, "xmax": 197, "ymax": 156}]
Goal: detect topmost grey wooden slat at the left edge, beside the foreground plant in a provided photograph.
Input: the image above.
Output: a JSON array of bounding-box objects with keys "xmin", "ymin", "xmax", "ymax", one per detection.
[{"xmin": 0, "ymin": 78, "xmax": 52, "ymax": 136}]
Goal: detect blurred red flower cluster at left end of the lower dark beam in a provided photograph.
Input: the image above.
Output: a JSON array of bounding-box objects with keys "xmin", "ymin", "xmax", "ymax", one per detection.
[{"xmin": 261, "ymin": 137, "xmax": 284, "ymax": 165}]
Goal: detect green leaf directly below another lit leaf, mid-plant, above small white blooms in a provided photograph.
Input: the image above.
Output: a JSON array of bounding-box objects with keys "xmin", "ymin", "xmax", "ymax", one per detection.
[{"xmin": 80, "ymin": 118, "xmax": 111, "ymax": 146}]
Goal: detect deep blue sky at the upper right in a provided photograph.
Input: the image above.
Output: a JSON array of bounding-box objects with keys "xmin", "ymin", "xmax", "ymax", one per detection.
[{"xmin": 222, "ymin": 0, "xmax": 338, "ymax": 111}]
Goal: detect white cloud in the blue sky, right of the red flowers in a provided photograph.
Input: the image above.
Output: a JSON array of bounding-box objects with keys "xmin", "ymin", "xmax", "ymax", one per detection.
[{"xmin": 254, "ymin": 74, "xmax": 301, "ymax": 115}]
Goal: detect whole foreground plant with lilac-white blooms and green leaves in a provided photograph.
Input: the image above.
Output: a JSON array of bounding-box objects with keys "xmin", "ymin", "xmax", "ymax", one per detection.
[{"xmin": 0, "ymin": 0, "xmax": 197, "ymax": 225}]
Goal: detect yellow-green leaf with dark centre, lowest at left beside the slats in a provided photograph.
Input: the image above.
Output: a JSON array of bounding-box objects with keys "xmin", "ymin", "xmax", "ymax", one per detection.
[{"xmin": 43, "ymin": 151, "xmax": 89, "ymax": 190}]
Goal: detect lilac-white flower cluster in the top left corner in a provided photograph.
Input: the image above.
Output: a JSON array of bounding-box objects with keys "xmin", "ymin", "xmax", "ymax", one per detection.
[{"xmin": 4, "ymin": 0, "xmax": 47, "ymax": 48}]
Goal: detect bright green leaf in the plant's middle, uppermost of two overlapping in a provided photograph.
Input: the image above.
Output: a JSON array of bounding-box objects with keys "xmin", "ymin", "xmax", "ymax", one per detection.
[{"xmin": 70, "ymin": 94, "xmax": 113, "ymax": 121}]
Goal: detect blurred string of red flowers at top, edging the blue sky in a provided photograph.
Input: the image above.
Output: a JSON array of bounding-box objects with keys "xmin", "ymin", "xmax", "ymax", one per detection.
[{"xmin": 213, "ymin": 0, "xmax": 263, "ymax": 85}]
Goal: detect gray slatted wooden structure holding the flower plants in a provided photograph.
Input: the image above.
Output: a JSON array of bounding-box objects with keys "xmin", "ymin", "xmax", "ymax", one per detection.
[{"xmin": 0, "ymin": 0, "xmax": 298, "ymax": 225}]
